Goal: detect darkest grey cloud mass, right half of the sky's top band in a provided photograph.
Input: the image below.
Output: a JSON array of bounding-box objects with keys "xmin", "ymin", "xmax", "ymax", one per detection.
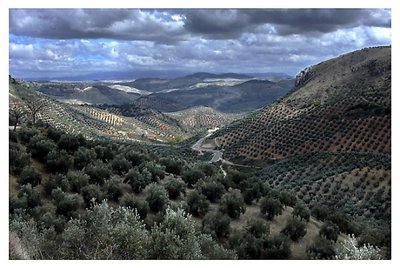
[{"xmin": 184, "ymin": 9, "xmax": 391, "ymax": 39}]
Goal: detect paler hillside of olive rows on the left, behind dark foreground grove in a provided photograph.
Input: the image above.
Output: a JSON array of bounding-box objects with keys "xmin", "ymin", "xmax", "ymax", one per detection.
[{"xmin": 9, "ymin": 81, "xmax": 188, "ymax": 142}]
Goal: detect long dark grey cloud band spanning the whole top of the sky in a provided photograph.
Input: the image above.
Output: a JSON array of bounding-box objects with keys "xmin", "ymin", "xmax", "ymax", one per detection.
[{"xmin": 10, "ymin": 9, "xmax": 391, "ymax": 43}]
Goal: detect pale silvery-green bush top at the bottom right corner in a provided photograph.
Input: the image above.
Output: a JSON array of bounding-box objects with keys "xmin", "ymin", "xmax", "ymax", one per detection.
[{"xmin": 335, "ymin": 235, "xmax": 383, "ymax": 260}]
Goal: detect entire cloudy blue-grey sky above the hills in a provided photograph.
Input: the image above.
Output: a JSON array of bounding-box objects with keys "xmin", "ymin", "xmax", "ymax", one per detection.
[{"xmin": 9, "ymin": 9, "xmax": 391, "ymax": 79}]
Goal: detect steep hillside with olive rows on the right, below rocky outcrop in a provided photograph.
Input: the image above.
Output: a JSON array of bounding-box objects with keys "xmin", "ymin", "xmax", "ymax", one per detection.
[{"xmin": 208, "ymin": 47, "xmax": 391, "ymax": 232}]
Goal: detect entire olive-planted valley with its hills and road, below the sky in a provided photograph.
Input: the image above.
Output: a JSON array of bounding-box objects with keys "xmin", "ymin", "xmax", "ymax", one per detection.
[{"xmin": 9, "ymin": 46, "xmax": 392, "ymax": 259}]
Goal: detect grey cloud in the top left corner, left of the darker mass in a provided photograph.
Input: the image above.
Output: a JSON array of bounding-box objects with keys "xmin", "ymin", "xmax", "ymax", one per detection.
[{"xmin": 10, "ymin": 9, "xmax": 188, "ymax": 43}]
